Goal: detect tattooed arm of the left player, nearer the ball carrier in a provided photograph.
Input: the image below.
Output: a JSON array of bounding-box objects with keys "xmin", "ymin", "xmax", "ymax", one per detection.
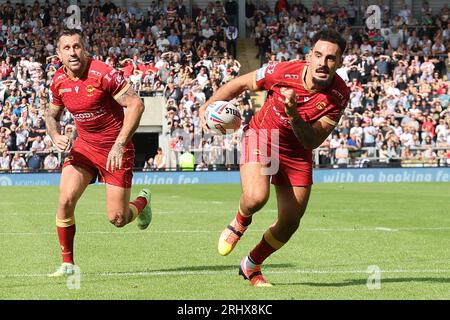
[{"xmin": 106, "ymin": 85, "xmax": 145, "ymax": 172}]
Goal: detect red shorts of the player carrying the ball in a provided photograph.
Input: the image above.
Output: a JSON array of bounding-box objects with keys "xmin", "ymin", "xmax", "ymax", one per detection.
[{"xmin": 240, "ymin": 126, "xmax": 313, "ymax": 187}]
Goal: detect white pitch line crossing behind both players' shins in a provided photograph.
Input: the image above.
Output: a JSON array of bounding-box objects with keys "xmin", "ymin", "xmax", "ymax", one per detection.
[{"xmin": 0, "ymin": 227, "xmax": 450, "ymax": 236}]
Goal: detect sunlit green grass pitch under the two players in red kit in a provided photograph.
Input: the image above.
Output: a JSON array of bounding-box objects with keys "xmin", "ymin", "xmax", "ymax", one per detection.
[{"xmin": 0, "ymin": 183, "xmax": 450, "ymax": 300}]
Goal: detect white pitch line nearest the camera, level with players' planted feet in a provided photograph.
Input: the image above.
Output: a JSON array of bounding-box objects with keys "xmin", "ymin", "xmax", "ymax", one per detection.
[{"xmin": 0, "ymin": 269, "xmax": 450, "ymax": 278}]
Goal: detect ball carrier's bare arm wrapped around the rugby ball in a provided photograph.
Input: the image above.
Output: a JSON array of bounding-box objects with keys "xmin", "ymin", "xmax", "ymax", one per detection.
[{"xmin": 199, "ymin": 71, "xmax": 259, "ymax": 129}]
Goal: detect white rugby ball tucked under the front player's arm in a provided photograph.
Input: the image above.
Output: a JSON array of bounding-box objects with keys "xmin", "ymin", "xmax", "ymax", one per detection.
[{"xmin": 205, "ymin": 101, "xmax": 242, "ymax": 134}]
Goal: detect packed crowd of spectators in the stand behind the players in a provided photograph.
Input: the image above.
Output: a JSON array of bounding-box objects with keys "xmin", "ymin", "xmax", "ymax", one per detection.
[{"xmin": 0, "ymin": 0, "xmax": 450, "ymax": 172}]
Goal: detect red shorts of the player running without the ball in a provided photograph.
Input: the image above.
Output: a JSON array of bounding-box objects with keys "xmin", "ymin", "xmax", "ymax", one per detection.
[{"xmin": 63, "ymin": 139, "xmax": 134, "ymax": 189}]
